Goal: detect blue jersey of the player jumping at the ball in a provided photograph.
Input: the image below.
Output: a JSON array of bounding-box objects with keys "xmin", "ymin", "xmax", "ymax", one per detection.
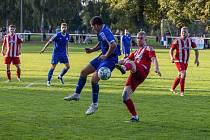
[{"xmin": 97, "ymin": 25, "xmax": 118, "ymax": 61}]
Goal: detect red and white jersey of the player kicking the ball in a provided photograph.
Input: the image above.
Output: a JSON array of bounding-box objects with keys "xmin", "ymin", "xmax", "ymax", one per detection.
[{"xmin": 128, "ymin": 46, "xmax": 156, "ymax": 70}]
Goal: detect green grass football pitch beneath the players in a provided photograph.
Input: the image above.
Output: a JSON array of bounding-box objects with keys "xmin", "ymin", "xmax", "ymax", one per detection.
[{"xmin": 0, "ymin": 44, "xmax": 210, "ymax": 140}]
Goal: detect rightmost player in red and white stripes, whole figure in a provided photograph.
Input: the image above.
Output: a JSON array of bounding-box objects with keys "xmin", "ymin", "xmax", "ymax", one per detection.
[{"xmin": 169, "ymin": 27, "xmax": 199, "ymax": 96}]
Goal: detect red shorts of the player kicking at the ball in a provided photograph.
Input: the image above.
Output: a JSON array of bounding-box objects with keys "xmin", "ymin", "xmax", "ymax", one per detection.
[{"xmin": 125, "ymin": 66, "xmax": 149, "ymax": 91}]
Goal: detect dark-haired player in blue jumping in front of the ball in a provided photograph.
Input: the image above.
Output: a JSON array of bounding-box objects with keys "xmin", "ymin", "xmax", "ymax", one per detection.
[{"xmin": 64, "ymin": 16, "xmax": 118, "ymax": 115}]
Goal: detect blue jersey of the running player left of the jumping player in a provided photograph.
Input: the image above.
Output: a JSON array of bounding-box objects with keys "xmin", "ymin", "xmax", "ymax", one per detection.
[{"xmin": 51, "ymin": 32, "xmax": 70, "ymax": 55}]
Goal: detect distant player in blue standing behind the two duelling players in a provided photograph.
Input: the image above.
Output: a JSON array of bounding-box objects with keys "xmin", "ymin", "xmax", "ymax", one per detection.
[{"xmin": 122, "ymin": 30, "xmax": 132, "ymax": 58}]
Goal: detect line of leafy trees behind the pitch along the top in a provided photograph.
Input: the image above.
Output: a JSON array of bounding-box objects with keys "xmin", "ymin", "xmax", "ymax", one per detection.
[{"xmin": 0, "ymin": 0, "xmax": 210, "ymax": 34}]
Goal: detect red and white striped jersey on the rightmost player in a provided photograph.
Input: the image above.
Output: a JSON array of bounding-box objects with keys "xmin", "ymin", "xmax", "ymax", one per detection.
[{"xmin": 171, "ymin": 38, "xmax": 196, "ymax": 64}]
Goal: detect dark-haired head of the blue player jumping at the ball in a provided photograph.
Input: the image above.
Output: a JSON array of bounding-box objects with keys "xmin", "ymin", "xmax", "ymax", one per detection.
[{"xmin": 90, "ymin": 16, "xmax": 104, "ymax": 33}]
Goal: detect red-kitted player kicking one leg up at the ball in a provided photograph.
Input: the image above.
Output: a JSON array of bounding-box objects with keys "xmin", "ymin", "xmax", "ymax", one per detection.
[{"xmin": 116, "ymin": 31, "xmax": 161, "ymax": 122}]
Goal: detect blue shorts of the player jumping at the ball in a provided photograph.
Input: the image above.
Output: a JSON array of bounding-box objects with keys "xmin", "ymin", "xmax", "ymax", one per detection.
[{"xmin": 90, "ymin": 57, "xmax": 116, "ymax": 72}]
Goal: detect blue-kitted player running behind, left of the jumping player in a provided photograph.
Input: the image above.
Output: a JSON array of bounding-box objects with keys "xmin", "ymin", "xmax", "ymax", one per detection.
[{"xmin": 40, "ymin": 23, "xmax": 70, "ymax": 86}]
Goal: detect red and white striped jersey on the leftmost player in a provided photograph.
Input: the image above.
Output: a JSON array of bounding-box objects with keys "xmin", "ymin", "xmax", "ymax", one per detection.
[{"xmin": 3, "ymin": 34, "xmax": 23, "ymax": 57}]
